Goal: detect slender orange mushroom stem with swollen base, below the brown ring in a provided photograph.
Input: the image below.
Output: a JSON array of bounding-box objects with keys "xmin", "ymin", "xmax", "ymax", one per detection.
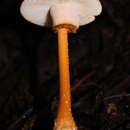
[{"xmin": 54, "ymin": 28, "xmax": 77, "ymax": 130}]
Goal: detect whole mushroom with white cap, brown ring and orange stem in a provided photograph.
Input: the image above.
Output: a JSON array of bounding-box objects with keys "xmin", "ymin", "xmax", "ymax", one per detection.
[{"xmin": 20, "ymin": 0, "xmax": 102, "ymax": 130}]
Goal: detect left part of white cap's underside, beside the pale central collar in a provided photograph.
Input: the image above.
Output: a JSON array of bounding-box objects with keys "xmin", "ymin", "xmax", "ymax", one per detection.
[{"xmin": 20, "ymin": 0, "xmax": 51, "ymax": 26}]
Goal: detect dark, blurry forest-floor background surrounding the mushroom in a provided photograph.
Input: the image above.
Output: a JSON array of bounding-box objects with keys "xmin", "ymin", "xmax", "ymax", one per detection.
[{"xmin": 0, "ymin": 0, "xmax": 130, "ymax": 130}]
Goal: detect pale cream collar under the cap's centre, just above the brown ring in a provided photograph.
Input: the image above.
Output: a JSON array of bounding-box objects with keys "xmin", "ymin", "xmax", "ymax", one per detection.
[{"xmin": 50, "ymin": 2, "xmax": 80, "ymax": 28}]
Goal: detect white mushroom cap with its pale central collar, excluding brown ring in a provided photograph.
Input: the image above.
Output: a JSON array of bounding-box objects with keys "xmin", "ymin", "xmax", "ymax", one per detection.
[{"xmin": 20, "ymin": 0, "xmax": 102, "ymax": 28}]
